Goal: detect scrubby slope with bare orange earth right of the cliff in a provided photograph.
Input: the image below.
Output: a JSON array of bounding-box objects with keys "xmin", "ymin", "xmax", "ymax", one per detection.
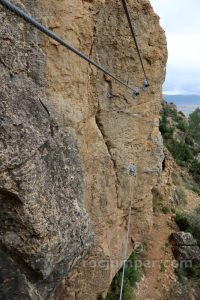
[{"xmin": 136, "ymin": 102, "xmax": 200, "ymax": 300}]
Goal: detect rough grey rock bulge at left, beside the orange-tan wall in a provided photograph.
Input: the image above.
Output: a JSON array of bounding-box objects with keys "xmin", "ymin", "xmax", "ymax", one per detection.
[{"xmin": 0, "ymin": 1, "xmax": 93, "ymax": 300}]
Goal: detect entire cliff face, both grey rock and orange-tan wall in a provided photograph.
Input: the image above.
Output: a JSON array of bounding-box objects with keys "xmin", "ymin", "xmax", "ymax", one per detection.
[{"xmin": 0, "ymin": 0, "xmax": 167, "ymax": 300}]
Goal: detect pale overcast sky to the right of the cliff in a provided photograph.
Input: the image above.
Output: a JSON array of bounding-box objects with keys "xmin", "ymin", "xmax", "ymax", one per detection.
[{"xmin": 150, "ymin": 0, "xmax": 200, "ymax": 95}]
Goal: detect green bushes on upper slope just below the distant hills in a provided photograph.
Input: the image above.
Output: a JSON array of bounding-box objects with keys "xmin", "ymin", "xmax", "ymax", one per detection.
[{"xmin": 160, "ymin": 104, "xmax": 200, "ymax": 184}]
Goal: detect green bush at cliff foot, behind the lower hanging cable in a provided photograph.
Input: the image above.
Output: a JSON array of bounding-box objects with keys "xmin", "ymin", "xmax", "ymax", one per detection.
[{"xmin": 99, "ymin": 252, "xmax": 140, "ymax": 300}]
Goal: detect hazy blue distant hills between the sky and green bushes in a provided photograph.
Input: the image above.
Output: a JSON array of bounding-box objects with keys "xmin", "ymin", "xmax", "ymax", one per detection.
[{"xmin": 164, "ymin": 95, "xmax": 200, "ymax": 116}]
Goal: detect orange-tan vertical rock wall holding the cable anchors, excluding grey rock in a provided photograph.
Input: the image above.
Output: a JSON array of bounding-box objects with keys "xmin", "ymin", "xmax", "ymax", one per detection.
[{"xmin": 36, "ymin": 0, "xmax": 166, "ymax": 299}]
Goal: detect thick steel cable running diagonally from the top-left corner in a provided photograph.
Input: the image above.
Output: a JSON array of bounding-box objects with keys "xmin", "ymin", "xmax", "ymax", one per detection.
[{"xmin": 0, "ymin": 0, "xmax": 136, "ymax": 92}]
